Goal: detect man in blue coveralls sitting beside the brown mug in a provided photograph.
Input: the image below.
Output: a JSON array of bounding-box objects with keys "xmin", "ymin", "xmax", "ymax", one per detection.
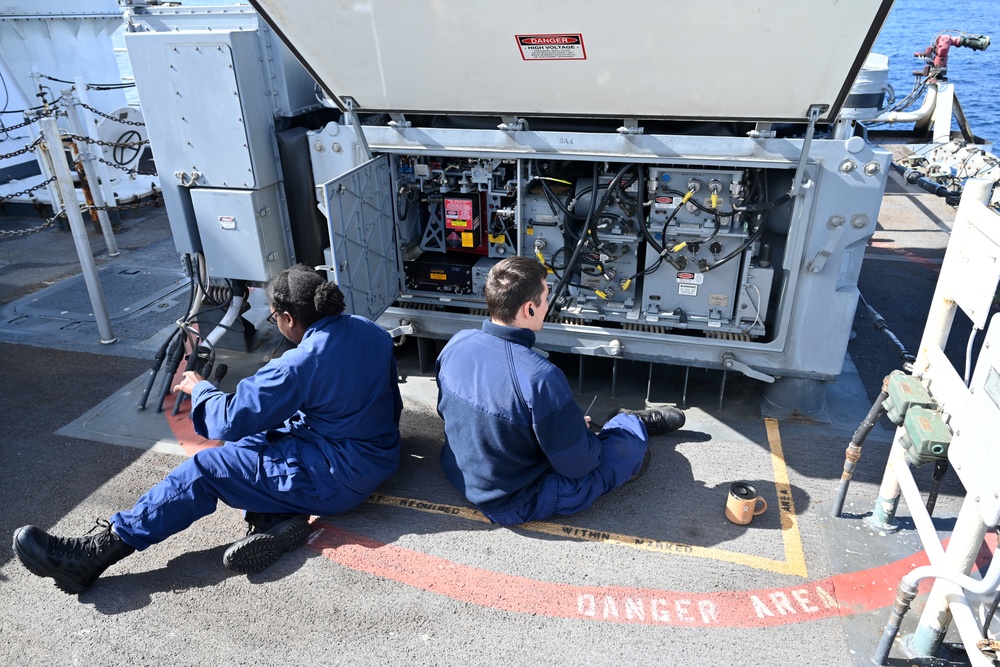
[{"xmin": 437, "ymin": 257, "xmax": 684, "ymax": 525}]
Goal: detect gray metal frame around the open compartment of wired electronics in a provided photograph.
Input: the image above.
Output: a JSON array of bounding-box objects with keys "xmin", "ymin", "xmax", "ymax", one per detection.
[{"xmin": 310, "ymin": 120, "xmax": 890, "ymax": 380}]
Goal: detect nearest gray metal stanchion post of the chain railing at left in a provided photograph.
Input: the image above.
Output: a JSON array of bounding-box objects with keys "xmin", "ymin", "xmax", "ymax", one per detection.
[{"xmin": 38, "ymin": 116, "xmax": 118, "ymax": 345}]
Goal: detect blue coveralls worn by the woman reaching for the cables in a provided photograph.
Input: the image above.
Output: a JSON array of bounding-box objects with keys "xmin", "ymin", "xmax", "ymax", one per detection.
[{"xmin": 111, "ymin": 315, "xmax": 403, "ymax": 550}]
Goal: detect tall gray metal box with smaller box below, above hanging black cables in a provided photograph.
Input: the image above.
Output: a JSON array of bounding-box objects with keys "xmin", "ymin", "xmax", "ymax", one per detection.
[{"xmin": 125, "ymin": 7, "xmax": 320, "ymax": 282}]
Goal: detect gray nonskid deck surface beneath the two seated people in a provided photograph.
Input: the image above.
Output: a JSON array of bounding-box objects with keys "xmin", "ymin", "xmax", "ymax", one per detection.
[{"xmin": 0, "ymin": 174, "xmax": 992, "ymax": 665}]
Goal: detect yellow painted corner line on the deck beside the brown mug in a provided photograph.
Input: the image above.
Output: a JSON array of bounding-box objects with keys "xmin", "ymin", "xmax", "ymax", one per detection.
[{"xmin": 368, "ymin": 419, "xmax": 807, "ymax": 577}]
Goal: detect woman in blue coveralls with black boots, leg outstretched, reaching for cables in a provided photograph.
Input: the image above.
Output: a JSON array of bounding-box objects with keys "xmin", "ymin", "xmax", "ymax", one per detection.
[{"xmin": 14, "ymin": 264, "xmax": 402, "ymax": 593}]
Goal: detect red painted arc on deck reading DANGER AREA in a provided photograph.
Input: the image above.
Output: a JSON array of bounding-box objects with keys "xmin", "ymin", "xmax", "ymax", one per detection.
[{"xmin": 309, "ymin": 520, "xmax": 996, "ymax": 628}]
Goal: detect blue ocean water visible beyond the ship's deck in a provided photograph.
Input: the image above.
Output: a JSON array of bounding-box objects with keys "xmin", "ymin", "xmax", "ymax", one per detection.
[{"xmin": 114, "ymin": 0, "xmax": 1000, "ymax": 143}]
